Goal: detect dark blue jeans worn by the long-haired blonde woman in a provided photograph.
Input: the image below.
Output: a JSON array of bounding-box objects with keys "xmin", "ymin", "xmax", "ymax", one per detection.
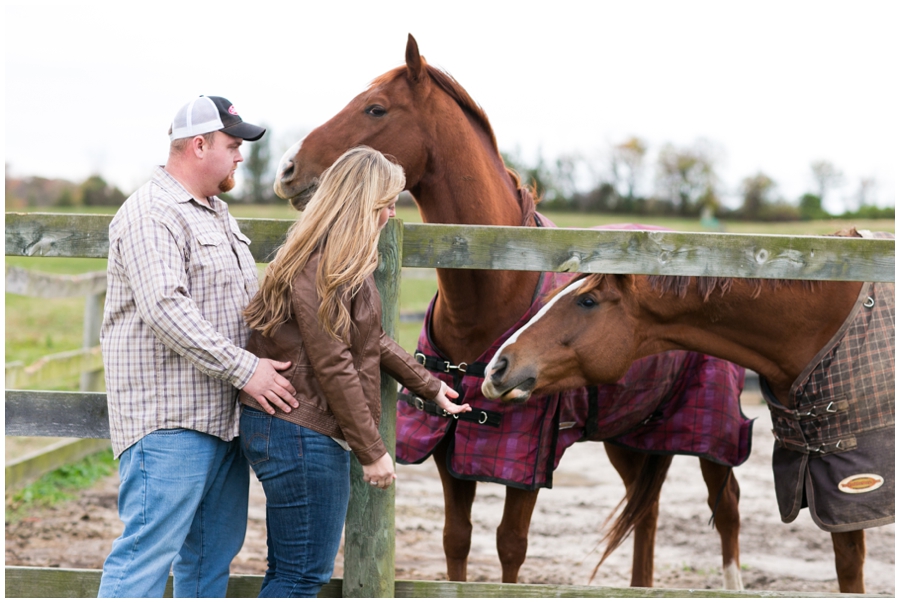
[{"xmin": 240, "ymin": 406, "xmax": 350, "ymax": 597}]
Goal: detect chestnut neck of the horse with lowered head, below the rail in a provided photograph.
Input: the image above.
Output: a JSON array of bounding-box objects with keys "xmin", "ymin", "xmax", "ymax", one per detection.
[{"xmin": 644, "ymin": 281, "xmax": 861, "ymax": 404}]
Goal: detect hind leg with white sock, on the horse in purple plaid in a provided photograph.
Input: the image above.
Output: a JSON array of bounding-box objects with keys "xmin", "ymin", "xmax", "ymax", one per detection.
[{"xmin": 700, "ymin": 458, "xmax": 744, "ymax": 590}]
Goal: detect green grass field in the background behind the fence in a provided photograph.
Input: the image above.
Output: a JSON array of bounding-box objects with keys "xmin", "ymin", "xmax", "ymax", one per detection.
[{"xmin": 6, "ymin": 204, "xmax": 895, "ymax": 368}]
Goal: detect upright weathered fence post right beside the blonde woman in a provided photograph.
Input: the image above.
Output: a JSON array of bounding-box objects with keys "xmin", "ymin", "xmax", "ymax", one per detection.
[{"xmin": 343, "ymin": 220, "xmax": 403, "ymax": 597}]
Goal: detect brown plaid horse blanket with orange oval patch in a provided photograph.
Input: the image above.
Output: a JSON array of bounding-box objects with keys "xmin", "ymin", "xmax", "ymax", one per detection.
[{"xmin": 760, "ymin": 274, "xmax": 894, "ymax": 532}]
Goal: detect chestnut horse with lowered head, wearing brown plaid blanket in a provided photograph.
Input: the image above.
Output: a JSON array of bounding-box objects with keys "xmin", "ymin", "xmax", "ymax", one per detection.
[{"xmin": 482, "ymin": 258, "xmax": 894, "ymax": 593}]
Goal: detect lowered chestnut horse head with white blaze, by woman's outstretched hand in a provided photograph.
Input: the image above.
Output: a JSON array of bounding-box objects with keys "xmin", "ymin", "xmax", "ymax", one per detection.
[{"xmin": 481, "ymin": 275, "xmax": 637, "ymax": 402}]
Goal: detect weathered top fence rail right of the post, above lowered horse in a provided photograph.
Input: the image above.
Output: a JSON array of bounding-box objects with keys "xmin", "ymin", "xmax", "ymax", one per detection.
[{"xmin": 403, "ymin": 224, "xmax": 894, "ymax": 282}]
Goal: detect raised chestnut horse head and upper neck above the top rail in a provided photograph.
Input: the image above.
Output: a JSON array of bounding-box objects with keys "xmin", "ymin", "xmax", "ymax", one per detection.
[{"xmin": 274, "ymin": 35, "xmax": 519, "ymax": 225}]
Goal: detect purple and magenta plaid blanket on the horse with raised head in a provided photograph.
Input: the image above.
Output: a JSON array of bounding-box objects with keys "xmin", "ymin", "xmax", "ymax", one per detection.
[{"xmin": 396, "ymin": 225, "xmax": 752, "ymax": 490}]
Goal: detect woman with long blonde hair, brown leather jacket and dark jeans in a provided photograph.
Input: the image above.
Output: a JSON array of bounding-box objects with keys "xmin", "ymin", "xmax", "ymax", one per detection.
[{"xmin": 240, "ymin": 147, "xmax": 471, "ymax": 597}]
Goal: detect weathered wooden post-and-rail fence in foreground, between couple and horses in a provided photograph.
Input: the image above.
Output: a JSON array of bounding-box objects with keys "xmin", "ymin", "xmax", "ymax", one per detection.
[{"xmin": 6, "ymin": 213, "xmax": 894, "ymax": 597}]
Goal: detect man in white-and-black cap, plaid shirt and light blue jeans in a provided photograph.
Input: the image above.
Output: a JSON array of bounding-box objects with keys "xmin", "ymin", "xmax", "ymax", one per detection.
[{"xmin": 99, "ymin": 96, "xmax": 297, "ymax": 597}]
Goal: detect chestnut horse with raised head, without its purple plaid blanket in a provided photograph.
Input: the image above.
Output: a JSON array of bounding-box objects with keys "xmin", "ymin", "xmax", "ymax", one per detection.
[{"xmin": 275, "ymin": 36, "xmax": 741, "ymax": 589}]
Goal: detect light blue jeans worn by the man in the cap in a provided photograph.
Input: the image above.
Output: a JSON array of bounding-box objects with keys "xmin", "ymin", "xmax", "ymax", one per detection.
[{"xmin": 98, "ymin": 429, "xmax": 250, "ymax": 597}]
